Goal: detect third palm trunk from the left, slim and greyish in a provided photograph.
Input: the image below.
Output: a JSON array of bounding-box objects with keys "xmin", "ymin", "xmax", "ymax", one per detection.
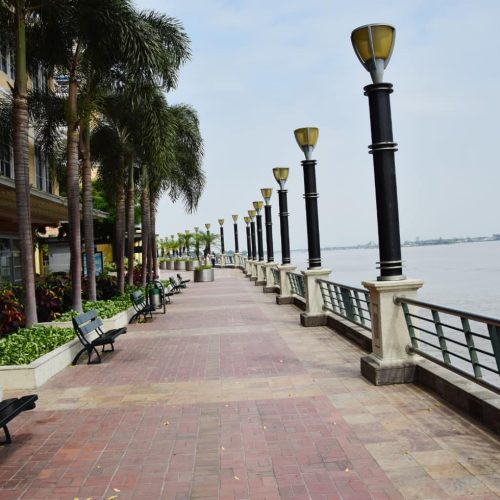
[{"xmin": 80, "ymin": 118, "xmax": 97, "ymax": 301}]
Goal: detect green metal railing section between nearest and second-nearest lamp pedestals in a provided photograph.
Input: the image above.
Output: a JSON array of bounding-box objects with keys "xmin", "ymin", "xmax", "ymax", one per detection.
[{"xmin": 317, "ymin": 280, "xmax": 372, "ymax": 331}]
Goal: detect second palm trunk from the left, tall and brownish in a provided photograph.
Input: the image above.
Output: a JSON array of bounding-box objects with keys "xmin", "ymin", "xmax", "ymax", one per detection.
[{"xmin": 66, "ymin": 46, "xmax": 82, "ymax": 312}]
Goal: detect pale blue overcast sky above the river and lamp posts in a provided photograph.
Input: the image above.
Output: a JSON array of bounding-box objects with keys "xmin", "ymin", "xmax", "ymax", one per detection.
[{"xmin": 136, "ymin": 0, "xmax": 500, "ymax": 249}]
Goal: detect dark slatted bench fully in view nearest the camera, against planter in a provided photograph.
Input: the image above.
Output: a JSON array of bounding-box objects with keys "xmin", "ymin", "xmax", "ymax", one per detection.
[{"xmin": 72, "ymin": 310, "xmax": 127, "ymax": 365}]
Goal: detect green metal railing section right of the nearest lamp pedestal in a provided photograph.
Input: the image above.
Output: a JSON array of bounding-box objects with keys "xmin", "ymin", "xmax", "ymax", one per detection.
[{"xmin": 395, "ymin": 297, "xmax": 500, "ymax": 390}]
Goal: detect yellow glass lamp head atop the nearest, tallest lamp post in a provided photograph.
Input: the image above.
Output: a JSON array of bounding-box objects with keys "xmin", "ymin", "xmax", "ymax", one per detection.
[{"xmin": 351, "ymin": 24, "xmax": 396, "ymax": 83}]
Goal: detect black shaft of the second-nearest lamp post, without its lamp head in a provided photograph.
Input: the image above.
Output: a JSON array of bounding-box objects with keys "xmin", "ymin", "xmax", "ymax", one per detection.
[{"xmin": 302, "ymin": 160, "xmax": 321, "ymax": 269}]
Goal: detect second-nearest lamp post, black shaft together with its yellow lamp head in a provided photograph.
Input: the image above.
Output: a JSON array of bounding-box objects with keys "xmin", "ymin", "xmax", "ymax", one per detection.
[{"xmin": 295, "ymin": 127, "xmax": 321, "ymax": 269}]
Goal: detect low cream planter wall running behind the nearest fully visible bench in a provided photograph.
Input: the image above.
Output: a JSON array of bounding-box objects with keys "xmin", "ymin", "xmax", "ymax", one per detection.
[{"xmin": 0, "ymin": 307, "xmax": 134, "ymax": 390}]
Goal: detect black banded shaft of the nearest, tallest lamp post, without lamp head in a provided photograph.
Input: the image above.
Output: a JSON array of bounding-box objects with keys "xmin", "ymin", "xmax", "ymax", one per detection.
[{"xmin": 364, "ymin": 83, "xmax": 405, "ymax": 281}]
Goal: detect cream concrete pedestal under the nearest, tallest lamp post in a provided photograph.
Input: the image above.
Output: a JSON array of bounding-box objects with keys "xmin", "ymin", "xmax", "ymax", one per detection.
[{"xmin": 361, "ymin": 279, "xmax": 424, "ymax": 385}]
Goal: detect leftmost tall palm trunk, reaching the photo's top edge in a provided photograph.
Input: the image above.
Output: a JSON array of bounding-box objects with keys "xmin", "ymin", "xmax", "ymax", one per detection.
[{"xmin": 13, "ymin": 0, "xmax": 37, "ymax": 327}]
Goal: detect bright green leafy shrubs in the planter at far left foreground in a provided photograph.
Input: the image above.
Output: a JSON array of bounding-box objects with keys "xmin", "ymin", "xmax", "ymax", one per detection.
[{"xmin": 0, "ymin": 326, "xmax": 75, "ymax": 366}]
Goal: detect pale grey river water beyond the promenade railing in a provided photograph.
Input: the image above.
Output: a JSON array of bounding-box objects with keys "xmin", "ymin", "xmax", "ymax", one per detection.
[{"xmin": 288, "ymin": 241, "xmax": 500, "ymax": 318}]
